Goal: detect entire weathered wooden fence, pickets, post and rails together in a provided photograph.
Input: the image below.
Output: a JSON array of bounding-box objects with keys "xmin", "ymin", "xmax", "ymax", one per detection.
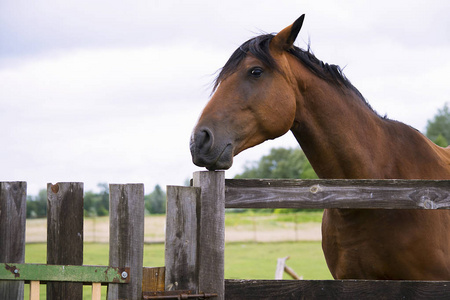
[{"xmin": 0, "ymin": 172, "xmax": 450, "ymax": 300}]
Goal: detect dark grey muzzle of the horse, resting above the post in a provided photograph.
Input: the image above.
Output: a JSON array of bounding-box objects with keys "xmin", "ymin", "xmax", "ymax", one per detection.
[{"xmin": 190, "ymin": 127, "xmax": 233, "ymax": 171}]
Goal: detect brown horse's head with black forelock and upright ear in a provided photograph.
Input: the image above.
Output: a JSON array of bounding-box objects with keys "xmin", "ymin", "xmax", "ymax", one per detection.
[{"xmin": 190, "ymin": 15, "xmax": 304, "ymax": 170}]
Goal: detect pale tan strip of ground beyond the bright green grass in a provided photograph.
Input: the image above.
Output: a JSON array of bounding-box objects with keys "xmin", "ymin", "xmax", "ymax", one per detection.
[{"xmin": 26, "ymin": 216, "xmax": 321, "ymax": 243}]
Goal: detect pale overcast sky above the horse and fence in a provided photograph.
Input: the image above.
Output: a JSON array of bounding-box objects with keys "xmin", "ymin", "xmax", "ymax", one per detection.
[{"xmin": 0, "ymin": 0, "xmax": 450, "ymax": 194}]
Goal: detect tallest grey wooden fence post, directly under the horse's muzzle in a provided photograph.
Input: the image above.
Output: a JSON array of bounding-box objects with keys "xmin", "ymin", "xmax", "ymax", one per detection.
[{"xmin": 193, "ymin": 171, "xmax": 225, "ymax": 299}]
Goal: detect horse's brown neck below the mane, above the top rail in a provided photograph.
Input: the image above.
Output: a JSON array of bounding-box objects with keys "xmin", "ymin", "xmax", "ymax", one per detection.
[{"xmin": 291, "ymin": 78, "xmax": 417, "ymax": 179}]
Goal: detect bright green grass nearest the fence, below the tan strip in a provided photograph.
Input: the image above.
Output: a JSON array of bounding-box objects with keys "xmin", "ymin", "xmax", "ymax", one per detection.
[{"xmin": 25, "ymin": 242, "xmax": 332, "ymax": 299}]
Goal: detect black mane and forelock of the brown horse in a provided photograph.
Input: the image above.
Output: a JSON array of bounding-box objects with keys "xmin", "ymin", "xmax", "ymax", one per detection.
[{"xmin": 213, "ymin": 34, "xmax": 373, "ymax": 115}]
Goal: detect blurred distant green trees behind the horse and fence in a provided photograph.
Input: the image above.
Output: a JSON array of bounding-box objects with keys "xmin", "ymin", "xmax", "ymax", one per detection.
[{"xmin": 27, "ymin": 103, "xmax": 450, "ymax": 218}]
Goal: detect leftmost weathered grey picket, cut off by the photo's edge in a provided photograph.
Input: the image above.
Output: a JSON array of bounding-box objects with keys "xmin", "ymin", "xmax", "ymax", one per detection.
[{"xmin": 0, "ymin": 182, "xmax": 27, "ymax": 299}]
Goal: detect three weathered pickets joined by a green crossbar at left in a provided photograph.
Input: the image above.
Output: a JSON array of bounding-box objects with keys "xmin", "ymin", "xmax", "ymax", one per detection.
[{"xmin": 0, "ymin": 182, "xmax": 146, "ymax": 299}]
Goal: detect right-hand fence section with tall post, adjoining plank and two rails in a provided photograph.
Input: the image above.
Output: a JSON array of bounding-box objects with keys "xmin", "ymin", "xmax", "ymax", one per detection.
[{"xmin": 166, "ymin": 172, "xmax": 450, "ymax": 300}]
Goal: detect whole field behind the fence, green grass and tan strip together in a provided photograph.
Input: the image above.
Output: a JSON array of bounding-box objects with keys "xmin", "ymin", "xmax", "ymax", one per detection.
[{"xmin": 25, "ymin": 210, "xmax": 331, "ymax": 299}]
